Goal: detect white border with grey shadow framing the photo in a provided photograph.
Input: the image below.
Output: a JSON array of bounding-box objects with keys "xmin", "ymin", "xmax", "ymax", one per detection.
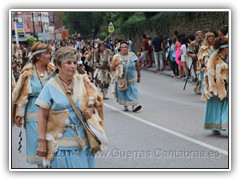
[{"xmin": 0, "ymin": 0, "xmax": 240, "ymax": 180}]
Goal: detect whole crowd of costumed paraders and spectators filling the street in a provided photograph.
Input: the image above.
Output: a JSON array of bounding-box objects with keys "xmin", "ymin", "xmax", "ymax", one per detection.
[{"xmin": 12, "ymin": 26, "xmax": 228, "ymax": 168}]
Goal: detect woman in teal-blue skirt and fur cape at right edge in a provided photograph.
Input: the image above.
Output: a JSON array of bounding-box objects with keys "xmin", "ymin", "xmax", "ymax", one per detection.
[{"xmin": 202, "ymin": 37, "xmax": 228, "ymax": 135}]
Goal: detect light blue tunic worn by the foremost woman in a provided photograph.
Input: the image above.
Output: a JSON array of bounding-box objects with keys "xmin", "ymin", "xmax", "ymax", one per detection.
[{"xmin": 36, "ymin": 77, "xmax": 95, "ymax": 168}]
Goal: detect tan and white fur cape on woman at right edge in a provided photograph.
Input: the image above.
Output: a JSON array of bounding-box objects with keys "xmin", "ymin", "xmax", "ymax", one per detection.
[{"xmin": 201, "ymin": 54, "xmax": 228, "ymax": 101}]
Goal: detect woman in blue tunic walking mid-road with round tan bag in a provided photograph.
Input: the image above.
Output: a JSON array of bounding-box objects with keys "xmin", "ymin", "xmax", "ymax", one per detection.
[{"xmin": 111, "ymin": 41, "xmax": 142, "ymax": 112}]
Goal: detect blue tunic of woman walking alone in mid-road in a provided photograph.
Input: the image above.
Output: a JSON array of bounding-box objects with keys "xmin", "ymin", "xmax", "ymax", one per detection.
[{"xmin": 115, "ymin": 52, "xmax": 139, "ymax": 106}]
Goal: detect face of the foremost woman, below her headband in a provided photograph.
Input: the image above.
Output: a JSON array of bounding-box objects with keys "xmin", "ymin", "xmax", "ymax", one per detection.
[{"xmin": 58, "ymin": 58, "xmax": 77, "ymax": 76}]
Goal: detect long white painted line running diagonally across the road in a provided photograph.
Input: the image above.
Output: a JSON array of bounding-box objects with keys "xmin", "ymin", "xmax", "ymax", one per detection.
[{"xmin": 104, "ymin": 103, "xmax": 228, "ymax": 156}]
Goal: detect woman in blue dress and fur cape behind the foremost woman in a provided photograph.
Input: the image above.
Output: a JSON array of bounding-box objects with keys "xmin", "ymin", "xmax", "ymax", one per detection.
[{"xmin": 12, "ymin": 42, "xmax": 55, "ymax": 168}]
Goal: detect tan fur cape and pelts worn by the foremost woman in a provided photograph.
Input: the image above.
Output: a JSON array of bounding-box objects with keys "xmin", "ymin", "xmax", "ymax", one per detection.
[{"xmin": 42, "ymin": 74, "xmax": 104, "ymax": 166}]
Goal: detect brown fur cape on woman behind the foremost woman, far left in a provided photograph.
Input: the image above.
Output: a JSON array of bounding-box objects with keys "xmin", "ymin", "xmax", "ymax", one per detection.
[{"xmin": 12, "ymin": 63, "xmax": 55, "ymax": 125}]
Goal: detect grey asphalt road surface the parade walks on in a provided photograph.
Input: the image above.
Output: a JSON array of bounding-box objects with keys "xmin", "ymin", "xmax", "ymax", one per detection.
[{"xmin": 12, "ymin": 71, "xmax": 229, "ymax": 169}]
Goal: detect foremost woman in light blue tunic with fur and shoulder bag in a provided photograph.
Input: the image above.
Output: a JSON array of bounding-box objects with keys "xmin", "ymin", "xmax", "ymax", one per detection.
[{"xmin": 36, "ymin": 47, "xmax": 103, "ymax": 168}]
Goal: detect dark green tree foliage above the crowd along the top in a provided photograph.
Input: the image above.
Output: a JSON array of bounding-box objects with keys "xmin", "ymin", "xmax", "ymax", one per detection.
[{"xmin": 60, "ymin": 11, "xmax": 228, "ymax": 38}]
